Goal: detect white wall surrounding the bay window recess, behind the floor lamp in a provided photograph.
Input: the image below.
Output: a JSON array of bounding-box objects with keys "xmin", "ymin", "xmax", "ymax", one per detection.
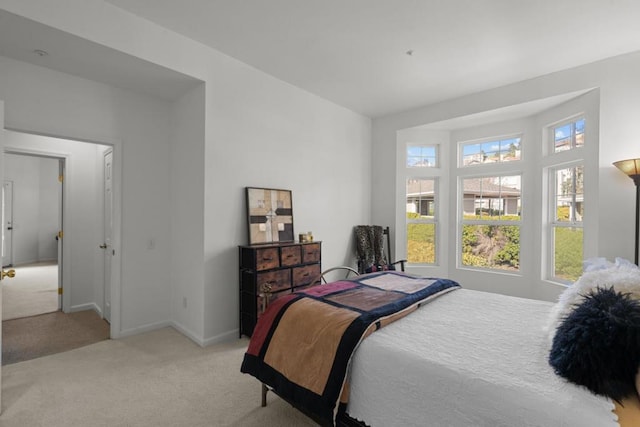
[{"xmin": 372, "ymin": 53, "xmax": 640, "ymax": 299}]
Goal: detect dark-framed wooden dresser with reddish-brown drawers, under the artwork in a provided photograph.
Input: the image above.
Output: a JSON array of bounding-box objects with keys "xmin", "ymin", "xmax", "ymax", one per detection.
[{"xmin": 239, "ymin": 242, "xmax": 321, "ymax": 336}]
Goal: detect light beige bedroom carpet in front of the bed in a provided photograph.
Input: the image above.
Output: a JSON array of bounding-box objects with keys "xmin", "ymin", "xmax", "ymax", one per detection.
[{"xmin": 0, "ymin": 328, "xmax": 316, "ymax": 427}]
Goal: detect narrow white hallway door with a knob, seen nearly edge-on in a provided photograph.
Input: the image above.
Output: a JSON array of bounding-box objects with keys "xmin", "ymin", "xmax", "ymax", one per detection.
[{"xmin": 100, "ymin": 149, "xmax": 113, "ymax": 322}]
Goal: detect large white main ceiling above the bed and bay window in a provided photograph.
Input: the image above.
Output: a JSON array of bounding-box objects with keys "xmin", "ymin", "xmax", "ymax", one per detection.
[{"xmin": 101, "ymin": 0, "xmax": 640, "ymax": 117}]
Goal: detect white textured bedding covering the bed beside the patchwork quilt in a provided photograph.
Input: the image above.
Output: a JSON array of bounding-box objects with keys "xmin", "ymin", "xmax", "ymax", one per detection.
[{"xmin": 347, "ymin": 289, "xmax": 618, "ymax": 427}]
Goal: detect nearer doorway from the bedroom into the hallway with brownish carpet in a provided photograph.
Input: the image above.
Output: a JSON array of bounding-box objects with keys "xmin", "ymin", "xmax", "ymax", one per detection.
[{"xmin": 2, "ymin": 131, "xmax": 119, "ymax": 364}]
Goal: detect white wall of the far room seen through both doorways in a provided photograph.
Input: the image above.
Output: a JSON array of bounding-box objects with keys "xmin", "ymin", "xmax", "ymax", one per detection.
[{"xmin": 5, "ymin": 155, "xmax": 59, "ymax": 265}]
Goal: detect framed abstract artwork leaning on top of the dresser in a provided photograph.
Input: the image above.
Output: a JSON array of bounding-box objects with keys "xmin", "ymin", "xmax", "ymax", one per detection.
[{"xmin": 246, "ymin": 187, "xmax": 293, "ymax": 245}]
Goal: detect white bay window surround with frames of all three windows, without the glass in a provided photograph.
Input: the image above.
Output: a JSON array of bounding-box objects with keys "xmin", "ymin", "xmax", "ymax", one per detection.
[{"xmin": 392, "ymin": 89, "xmax": 600, "ymax": 301}]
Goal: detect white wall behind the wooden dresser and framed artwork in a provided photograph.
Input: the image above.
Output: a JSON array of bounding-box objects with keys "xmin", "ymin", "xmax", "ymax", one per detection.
[{"xmin": 204, "ymin": 64, "xmax": 371, "ymax": 340}]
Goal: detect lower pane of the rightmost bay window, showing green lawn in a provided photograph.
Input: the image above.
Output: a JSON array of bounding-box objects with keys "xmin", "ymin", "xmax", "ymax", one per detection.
[{"xmin": 553, "ymin": 227, "xmax": 583, "ymax": 282}]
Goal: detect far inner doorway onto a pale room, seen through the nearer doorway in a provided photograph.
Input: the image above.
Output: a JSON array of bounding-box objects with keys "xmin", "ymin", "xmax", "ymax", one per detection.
[{"xmin": 2, "ymin": 153, "xmax": 65, "ymax": 321}]
